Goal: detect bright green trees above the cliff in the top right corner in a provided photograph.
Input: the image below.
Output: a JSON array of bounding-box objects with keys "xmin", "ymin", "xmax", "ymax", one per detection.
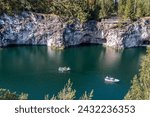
[{"xmin": 118, "ymin": 0, "xmax": 150, "ymax": 20}]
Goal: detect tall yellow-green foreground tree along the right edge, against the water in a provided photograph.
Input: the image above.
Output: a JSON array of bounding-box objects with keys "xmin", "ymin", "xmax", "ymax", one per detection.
[{"xmin": 125, "ymin": 48, "xmax": 150, "ymax": 100}]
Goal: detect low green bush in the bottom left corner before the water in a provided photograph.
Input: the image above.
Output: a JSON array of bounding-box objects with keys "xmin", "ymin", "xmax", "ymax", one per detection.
[{"xmin": 0, "ymin": 89, "xmax": 28, "ymax": 100}]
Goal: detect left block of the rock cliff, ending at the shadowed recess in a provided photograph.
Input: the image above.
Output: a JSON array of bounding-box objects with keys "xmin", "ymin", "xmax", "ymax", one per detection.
[{"xmin": 0, "ymin": 12, "xmax": 64, "ymax": 46}]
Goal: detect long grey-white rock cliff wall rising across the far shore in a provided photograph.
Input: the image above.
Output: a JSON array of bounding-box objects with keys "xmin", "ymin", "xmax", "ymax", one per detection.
[{"xmin": 0, "ymin": 12, "xmax": 150, "ymax": 49}]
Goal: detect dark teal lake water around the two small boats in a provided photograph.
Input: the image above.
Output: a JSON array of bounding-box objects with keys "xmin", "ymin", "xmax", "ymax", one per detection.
[{"xmin": 0, "ymin": 45, "xmax": 146, "ymax": 100}]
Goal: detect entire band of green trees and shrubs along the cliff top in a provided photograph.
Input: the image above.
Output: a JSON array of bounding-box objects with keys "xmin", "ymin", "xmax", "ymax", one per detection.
[{"xmin": 0, "ymin": 0, "xmax": 150, "ymax": 22}]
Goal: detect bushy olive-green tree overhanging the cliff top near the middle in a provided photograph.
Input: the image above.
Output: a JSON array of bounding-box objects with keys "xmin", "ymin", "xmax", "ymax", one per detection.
[{"xmin": 51, "ymin": 0, "xmax": 88, "ymax": 22}]
